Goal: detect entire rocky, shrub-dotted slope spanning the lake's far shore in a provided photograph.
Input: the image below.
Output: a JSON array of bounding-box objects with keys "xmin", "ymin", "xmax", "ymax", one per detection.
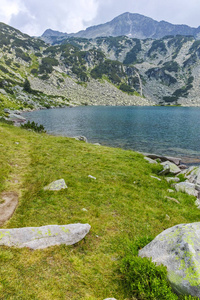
[{"xmin": 0, "ymin": 23, "xmax": 200, "ymax": 109}]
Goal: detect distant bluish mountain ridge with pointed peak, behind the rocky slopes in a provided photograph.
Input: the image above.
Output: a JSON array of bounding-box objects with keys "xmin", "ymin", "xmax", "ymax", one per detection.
[{"xmin": 42, "ymin": 12, "xmax": 200, "ymax": 44}]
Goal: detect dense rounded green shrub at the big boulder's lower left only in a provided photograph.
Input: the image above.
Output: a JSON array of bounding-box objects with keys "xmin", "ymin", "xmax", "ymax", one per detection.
[{"xmin": 120, "ymin": 256, "xmax": 178, "ymax": 300}]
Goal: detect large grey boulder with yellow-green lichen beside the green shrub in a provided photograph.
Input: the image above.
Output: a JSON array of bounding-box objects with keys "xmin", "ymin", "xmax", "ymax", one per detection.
[{"xmin": 139, "ymin": 222, "xmax": 200, "ymax": 297}]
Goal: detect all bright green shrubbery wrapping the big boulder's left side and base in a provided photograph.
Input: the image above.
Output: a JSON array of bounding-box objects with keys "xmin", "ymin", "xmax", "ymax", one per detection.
[{"xmin": 120, "ymin": 236, "xmax": 198, "ymax": 300}]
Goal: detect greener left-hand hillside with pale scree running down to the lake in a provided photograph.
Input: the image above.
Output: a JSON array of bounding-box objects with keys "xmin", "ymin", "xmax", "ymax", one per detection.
[{"xmin": 0, "ymin": 23, "xmax": 149, "ymax": 113}]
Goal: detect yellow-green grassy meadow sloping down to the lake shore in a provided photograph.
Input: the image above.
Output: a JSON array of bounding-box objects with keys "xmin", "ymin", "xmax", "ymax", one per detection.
[{"xmin": 0, "ymin": 123, "xmax": 200, "ymax": 300}]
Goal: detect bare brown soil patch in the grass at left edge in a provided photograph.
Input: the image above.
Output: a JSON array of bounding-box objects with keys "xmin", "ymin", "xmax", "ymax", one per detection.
[{"xmin": 0, "ymin": 192, "xmax": 18, "ymax": 226}]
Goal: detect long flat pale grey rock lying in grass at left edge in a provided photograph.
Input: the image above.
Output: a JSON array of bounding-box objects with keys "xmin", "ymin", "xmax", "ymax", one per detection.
[{"xmin": 0, "ymin": 223, "xmax": 91, "ymax": 250}]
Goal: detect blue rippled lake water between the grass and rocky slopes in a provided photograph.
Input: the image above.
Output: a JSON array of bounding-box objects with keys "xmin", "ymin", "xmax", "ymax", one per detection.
[{"xmin": 23, "ymin": 106, "xmax": 200, "ymax": 163}]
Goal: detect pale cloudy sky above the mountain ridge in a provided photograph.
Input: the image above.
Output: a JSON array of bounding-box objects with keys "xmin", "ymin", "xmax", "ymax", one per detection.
[{"xmin": 0, "ymin": 0, "xmax": 200, "ymax": 36}]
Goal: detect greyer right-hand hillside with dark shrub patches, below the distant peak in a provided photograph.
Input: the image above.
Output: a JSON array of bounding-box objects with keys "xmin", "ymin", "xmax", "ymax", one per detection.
[{"xmin": 39, "ymin": 36, "xmax": 200, "ymax": 106}]
